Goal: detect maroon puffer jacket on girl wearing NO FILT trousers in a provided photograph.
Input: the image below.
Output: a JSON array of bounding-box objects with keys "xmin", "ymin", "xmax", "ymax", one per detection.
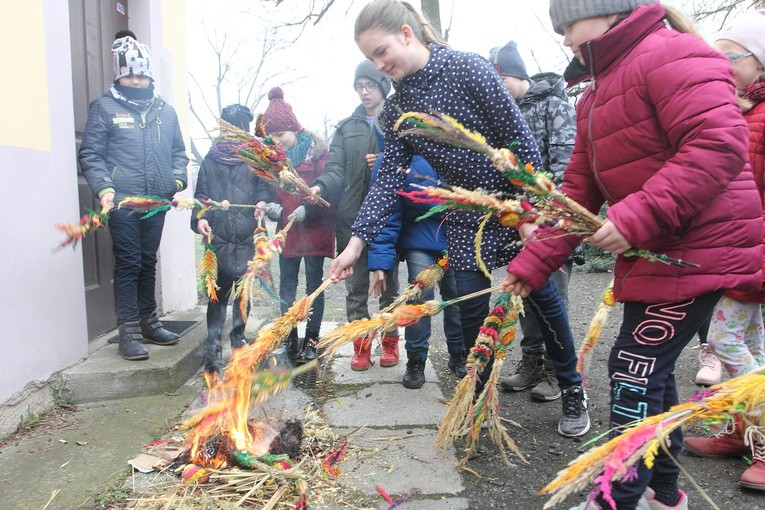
[{"xmin": 508, "ymin": 3, "xmax": 763, "ymax": 303}]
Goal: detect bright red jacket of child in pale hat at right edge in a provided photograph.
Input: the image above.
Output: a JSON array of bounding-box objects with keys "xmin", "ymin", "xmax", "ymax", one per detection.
[{"xmin": 726, "ymin": 82, "xmax": 765, "ymax": 303}]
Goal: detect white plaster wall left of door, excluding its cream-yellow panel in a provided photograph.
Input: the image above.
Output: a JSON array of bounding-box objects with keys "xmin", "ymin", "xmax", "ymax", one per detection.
[{"xmin": 0, "ymin": 0, "xmax": 88, "ymax": 404}]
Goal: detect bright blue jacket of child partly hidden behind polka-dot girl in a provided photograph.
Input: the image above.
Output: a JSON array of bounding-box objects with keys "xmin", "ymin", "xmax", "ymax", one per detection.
[{"xmin": 367, "ymin": 149, "xmax": 446, "ymax": 271}]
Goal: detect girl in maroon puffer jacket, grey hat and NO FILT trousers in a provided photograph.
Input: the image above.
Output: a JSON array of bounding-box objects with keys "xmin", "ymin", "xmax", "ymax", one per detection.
[{"xmin": 505, "ymin": 0, "xmax": 763, "ymax": 510}]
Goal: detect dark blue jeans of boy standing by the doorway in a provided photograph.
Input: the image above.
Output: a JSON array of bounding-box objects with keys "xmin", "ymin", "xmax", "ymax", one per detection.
[{"xmin": 109, "ymin": 207, "xmax": 165, "ymax": 324}]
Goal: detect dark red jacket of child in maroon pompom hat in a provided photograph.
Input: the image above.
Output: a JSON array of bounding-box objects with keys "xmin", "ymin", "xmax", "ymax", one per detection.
[{"xmin": 278, "ymin": 132, "xmax": 335, "ymax": 258}]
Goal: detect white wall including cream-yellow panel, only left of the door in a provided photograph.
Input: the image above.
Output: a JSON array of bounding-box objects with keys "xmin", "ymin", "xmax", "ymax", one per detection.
[{"xmin": 0, "ymin": 0, "xmax": 88, "ymax": 432}]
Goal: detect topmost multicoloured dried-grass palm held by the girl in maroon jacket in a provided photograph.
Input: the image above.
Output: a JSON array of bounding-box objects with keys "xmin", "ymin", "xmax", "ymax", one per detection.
[{"xmin": 393, "ymin": 111, "xmax": 699, "ymax": 267}]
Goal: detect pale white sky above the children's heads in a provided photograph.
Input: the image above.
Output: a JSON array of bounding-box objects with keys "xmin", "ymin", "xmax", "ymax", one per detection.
[{"xmin": 182, "ymin": 0, "xmax": 732, "ymax": 153}]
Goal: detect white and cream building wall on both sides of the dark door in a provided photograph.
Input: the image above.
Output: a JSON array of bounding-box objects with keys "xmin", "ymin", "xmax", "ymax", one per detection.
[{"xmin": 0, "ymin": 0, "xmax": 196, "ymax": 436}]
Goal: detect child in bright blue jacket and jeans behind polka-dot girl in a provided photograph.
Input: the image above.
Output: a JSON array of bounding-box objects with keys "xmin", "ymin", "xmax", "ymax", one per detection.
[{"xmin": 368, "ymin": 129, "xmax": 467, "ymax": 389}]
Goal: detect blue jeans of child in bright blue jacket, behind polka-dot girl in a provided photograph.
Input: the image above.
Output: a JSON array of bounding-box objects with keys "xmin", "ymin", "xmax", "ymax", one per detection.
[{"xmin": 404, "ymin": 250, "xmax": 465, "ymax": 361}]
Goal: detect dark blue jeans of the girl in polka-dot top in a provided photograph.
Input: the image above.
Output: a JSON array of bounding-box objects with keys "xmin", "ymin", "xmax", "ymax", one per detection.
[{"xmin": 455, "ymin": 271, "xmax": 582, "ymax": 389}]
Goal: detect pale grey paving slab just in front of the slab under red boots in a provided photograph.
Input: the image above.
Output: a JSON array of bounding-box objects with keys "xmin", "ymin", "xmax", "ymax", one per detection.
[{"xmin": 324, "ymin": 383, "xmax": 446, "ymax": 428}]
